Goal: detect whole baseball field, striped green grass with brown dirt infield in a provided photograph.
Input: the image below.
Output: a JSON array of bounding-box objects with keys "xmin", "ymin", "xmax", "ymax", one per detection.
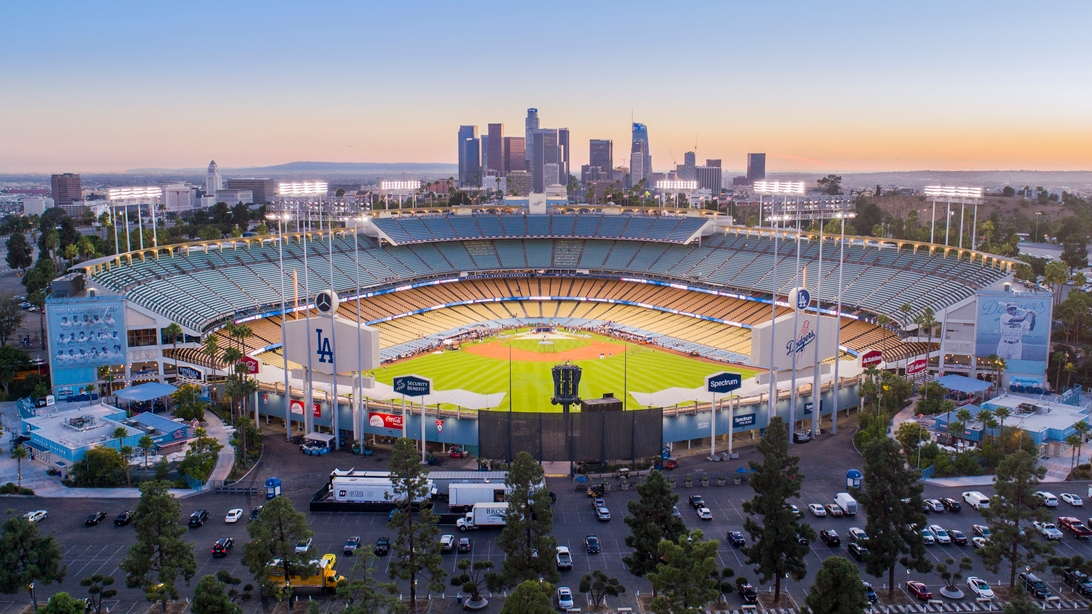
[{"xmin": 375, "ymin": 329, "xmax": 755, "ymax": 412}]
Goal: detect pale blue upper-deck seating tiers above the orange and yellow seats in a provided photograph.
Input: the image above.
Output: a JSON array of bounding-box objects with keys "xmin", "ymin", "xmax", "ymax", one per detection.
[{"xmin": 93, "ymin": 214, "xmax": 1008, "ymax": 338}]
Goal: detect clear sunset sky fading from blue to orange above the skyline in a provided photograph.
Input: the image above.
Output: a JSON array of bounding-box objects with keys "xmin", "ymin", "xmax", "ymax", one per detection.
[{"xmin": 0, "ymin": 0, "xmax": 1092, "ymax": 173}]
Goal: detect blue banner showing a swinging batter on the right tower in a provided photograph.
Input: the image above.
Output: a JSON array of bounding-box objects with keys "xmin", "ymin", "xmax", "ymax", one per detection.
[{"xmin": 974, "ymin": 292, "xmax": 1054, "ymax": 375}]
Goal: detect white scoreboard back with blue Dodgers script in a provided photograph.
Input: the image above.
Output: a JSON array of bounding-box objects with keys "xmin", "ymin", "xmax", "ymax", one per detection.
[{"xmin": 750, "ymin": 314, "xmax": 838, "ymax": 369}]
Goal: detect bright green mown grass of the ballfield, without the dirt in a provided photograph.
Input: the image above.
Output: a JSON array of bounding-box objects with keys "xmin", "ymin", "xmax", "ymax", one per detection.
[{"xmin": 375, "ymin": 335, "xmax": 755, "ymax": 412}]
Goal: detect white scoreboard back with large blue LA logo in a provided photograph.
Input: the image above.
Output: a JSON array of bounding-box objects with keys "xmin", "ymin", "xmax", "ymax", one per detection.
[{"xmin": 284, "ymin": 316, "xmax": 379, "ymax": 375}]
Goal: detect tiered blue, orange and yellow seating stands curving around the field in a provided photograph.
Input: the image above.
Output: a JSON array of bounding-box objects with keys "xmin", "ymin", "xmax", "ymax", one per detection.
[{"xmin": 74, "ymin": 208, "xmax": 1013, "ymax": 450}]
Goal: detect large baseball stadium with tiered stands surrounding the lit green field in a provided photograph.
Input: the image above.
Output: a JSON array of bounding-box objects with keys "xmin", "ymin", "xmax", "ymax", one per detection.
[{"xmin": 70, "ymin": 206, "xmax": 1013, "ymax": 456}]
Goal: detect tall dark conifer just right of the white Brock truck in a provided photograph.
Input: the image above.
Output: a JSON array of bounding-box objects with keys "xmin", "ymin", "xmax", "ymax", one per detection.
[{"xmin": 497, "ymin": 451, "xmax": 558, "ymax": 588}]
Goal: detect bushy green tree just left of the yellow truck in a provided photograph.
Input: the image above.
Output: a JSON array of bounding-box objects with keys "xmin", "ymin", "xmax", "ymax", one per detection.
[{"xmin": 242, "ymin": 497, "xmax": 317, "ymax": 600}]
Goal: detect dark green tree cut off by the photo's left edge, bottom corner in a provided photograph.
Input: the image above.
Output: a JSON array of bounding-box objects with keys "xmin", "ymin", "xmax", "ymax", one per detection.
[{"xmin": 0, "ymin": 509, "xmax": 68, "ymax": 607}]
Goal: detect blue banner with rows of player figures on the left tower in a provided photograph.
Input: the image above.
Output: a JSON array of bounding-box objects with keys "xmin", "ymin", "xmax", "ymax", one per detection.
[{"xmin": 46, "ymin": 296, "xmax": 129, "ymax": 386}]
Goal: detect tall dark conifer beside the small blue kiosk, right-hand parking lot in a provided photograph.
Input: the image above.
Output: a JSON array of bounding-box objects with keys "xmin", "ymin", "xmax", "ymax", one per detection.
[{"xmin": 853, "ymin": 437, "xmax": 927, "ymax": 599}]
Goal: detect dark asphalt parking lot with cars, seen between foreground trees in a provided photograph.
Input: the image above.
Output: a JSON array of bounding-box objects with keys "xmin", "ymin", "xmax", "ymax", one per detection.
[{"xmin": 10, "ymin": 426, "xmax": 1092, "ymax": 614}]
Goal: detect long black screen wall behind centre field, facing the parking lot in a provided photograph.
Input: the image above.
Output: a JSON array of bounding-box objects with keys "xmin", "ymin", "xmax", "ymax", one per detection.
[{"xmin": 478, "ymin": 409, "xmax": 664, "ymax": 462}]
